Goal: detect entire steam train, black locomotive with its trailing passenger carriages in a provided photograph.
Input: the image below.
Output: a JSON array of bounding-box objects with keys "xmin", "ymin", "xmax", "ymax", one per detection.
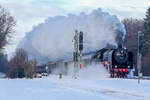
[{"xmin": 37, "ymin": 45, "xmax": 134, "ymax": 78}]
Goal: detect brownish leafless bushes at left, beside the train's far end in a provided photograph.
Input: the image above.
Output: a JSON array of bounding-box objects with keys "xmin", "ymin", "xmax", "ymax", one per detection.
[{"xmin": 8, "ymin": 49, "xmax": 36, "ymax": 78}]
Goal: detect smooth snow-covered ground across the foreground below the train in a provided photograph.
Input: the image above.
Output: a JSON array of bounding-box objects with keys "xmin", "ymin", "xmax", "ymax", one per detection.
[{"xmin": 0, "ymin": 75, "xmax": 150, "ymax": 100}]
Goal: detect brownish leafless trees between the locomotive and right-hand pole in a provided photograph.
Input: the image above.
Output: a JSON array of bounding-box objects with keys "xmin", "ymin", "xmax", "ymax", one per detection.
[{"xmin": 122, "ymin": 18, "xmax": 143, "ymax": 75}]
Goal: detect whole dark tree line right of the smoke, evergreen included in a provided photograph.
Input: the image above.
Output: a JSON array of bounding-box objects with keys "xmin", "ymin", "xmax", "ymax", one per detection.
[{"xmin": 122, "ymin": 7, "xmax": 150, "ymax": 76}]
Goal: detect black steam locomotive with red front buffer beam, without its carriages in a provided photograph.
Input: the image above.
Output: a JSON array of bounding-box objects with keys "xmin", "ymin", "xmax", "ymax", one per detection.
[{"xmin": 92, "ymin": 45, "xmax": 133, "ymax": 77}]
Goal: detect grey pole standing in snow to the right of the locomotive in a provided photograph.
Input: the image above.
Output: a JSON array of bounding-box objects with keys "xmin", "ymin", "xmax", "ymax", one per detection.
[{"xmin": 137, "ymin": 31, "xmax": 143, "ymax": 84}]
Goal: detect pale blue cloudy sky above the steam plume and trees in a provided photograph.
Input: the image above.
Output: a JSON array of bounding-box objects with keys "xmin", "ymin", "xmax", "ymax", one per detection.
[{"xmin": 0, "ymin": 0, "xmax": 150, "ymax": 52}]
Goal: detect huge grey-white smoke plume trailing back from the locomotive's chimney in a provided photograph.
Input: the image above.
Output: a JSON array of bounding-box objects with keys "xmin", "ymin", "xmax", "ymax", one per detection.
[{"xmin": 18, "ymin": 9, "xmax": 125, "ymax": 62}]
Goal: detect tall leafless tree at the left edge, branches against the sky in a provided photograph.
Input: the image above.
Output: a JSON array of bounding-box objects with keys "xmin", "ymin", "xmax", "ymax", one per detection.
[{"xmin": 0, "ymin": 6, "xmax": 16, "ymax": 50}]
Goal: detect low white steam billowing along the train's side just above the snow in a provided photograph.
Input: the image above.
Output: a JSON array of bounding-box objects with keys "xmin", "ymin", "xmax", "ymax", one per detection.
[{"xmin": 52, "ymin": 63, "xmax": 110, "ymax": 80}]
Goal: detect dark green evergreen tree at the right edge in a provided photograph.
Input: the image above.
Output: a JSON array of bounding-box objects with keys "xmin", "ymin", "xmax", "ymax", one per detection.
[{"xmin": 142, "ymin": 7, "xmax": 150, "ymax": 55}]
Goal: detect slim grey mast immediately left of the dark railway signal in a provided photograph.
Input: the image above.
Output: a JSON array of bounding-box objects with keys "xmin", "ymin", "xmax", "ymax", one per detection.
[{"xmin": 73, "ymin": 30, "xmax": 78, "ymax": 79}]
